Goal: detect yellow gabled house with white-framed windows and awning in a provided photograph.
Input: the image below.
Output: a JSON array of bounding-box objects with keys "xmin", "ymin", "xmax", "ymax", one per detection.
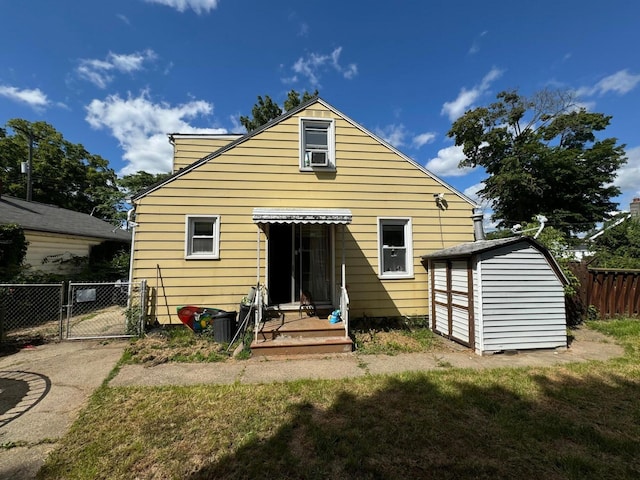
[{"xmin": 131, "ymin": 98, "xmax": 474, "ymax": 352}]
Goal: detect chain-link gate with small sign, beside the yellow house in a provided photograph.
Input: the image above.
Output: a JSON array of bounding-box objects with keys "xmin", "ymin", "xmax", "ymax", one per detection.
[{"xmin": 62, "ymin": 280, "xmax": 146, "ymax": 340}]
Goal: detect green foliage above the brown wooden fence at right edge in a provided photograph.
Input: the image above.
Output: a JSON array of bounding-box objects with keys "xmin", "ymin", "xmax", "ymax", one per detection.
[{"xmin": 591, "ymin": 217, "xmax": 640, "ymax": 269}]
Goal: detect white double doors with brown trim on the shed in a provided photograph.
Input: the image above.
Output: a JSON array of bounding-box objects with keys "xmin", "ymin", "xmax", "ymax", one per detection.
[{"xmin": 431, "ymin": 259, "xmax": 474, "ymax": 347}]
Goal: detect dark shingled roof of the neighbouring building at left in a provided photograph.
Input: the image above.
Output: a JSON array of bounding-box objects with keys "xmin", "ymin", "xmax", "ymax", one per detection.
[{"xmin": 0, "ymin": 195, "xmax": 131, "ymax": 242}]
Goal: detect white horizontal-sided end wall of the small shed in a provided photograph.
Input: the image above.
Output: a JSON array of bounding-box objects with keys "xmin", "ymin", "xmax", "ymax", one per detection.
[{"xmin": 476, "ymin": 244, "xmax": 566, "ymax": 351}]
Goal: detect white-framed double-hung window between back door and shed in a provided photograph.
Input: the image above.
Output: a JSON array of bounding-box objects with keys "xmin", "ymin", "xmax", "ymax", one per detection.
[{"xmin": 378, "ymin": 217, "xmax": 413, "ymax": 278}]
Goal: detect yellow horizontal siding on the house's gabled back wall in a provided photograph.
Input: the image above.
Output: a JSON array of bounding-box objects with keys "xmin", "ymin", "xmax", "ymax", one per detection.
[{"xmin": 134, "ymin": 103, "xmax": 473, "ymax": 323}]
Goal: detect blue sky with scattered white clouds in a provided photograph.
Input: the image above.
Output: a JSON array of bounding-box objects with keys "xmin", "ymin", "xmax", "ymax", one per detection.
[{"xmin": 0, "ymin": 0, "xmax": 640, "ymax": 216}]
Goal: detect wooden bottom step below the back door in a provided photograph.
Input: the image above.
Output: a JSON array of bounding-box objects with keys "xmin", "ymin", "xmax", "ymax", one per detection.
[{"xmin": 251, "ymin": 335, "xmax": 353, "ymax": 356}]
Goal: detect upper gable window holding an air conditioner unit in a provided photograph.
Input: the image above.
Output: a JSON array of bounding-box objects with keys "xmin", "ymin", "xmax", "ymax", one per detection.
[{"xmin": 300, "ymin": 118, "xmax": 336, "ymax": 171}]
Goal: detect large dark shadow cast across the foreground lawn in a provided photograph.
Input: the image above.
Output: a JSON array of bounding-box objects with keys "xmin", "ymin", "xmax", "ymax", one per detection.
[{"xmin": 182, "ymin": 370, "xmax": 640, "ymax": 479}]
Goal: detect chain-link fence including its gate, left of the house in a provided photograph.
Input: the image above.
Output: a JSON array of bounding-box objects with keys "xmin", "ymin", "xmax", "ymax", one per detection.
[{"xmin": 0, "ymin": 281, "xmax": 146, "ymax": 343}]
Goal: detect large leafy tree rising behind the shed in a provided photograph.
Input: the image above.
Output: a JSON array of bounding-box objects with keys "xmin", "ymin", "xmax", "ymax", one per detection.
[{"xmin": 448, "ymin": 90, "xmax": 626, "ymax": 233}]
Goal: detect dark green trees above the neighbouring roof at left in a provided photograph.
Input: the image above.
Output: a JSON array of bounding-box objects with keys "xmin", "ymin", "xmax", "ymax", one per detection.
[{"xmin": 0, "ymin": 119, "xmax": 121, "ymax": 222}]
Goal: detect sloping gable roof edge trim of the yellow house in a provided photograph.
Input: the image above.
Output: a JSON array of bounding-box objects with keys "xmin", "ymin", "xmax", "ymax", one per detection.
[{"xmin": 132, "ymin": 97, "xmax": 477, "ymax": 207}]
